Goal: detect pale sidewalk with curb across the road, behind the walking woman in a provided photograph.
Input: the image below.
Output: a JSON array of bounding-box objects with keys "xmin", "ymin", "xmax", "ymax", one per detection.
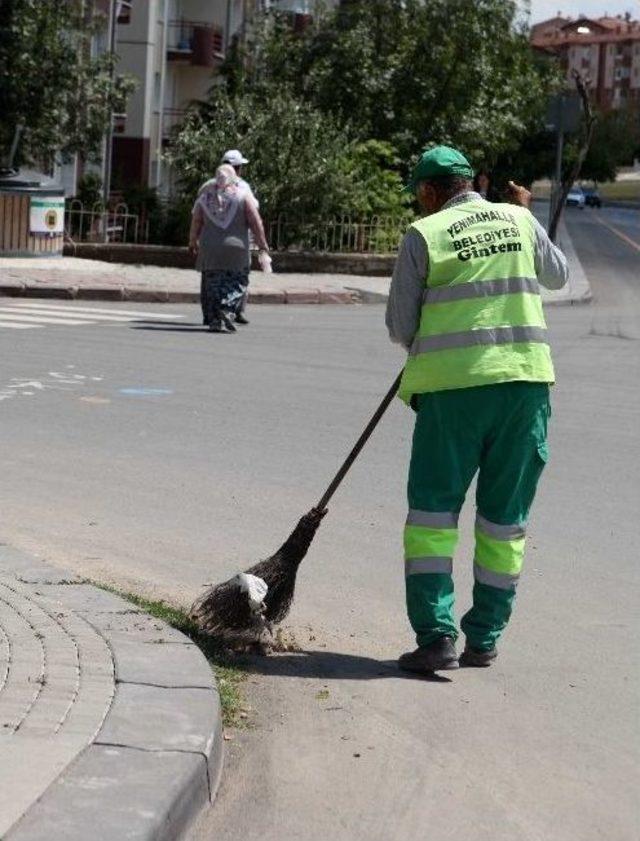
[{"xmin": 0, "ymin": 215, "xmax": 591, "ymax": 304}]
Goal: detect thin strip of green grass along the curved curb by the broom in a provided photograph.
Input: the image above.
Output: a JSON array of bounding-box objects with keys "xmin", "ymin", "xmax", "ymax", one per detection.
[{"xmin": 95, "ymin": 581, "xmax": 247, "ymax": 727}]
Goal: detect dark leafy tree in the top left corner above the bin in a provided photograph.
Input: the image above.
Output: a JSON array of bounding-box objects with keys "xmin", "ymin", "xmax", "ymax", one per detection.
[{"xmin": 0, "ymin": 0, "xmax": 134, "ymax": 169}]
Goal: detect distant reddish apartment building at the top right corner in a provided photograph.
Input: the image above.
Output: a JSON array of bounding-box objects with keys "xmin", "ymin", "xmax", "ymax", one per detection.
[{"xmin": 531, "ymin": 15, "xmax": 640, "ymax": 111}]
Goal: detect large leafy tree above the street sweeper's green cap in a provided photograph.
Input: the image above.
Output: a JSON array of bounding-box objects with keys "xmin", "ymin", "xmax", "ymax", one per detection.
[{"xmin": 218, "ymin": 0, "xmax": 557, "ymax": 169}]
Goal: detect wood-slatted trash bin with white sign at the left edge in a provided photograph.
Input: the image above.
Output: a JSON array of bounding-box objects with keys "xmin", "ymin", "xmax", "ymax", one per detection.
[{"xmin": 0, "ymin": 169, "xmax": 64, "ymax": 257}]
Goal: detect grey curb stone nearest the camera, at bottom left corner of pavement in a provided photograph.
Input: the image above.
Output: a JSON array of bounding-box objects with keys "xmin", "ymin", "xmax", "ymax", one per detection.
[{"xmin": 4, "ymin": 745, "xmax": 209, "ymax": 841}]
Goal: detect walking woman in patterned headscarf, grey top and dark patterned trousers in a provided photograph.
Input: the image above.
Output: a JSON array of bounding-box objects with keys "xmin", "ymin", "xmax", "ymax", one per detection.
[{"xmin": 189, "ymin": 164, "xmax": 269, "ymax": 333}]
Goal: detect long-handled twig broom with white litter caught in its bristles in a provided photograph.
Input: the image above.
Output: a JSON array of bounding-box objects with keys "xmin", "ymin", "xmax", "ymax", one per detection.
[{"xmin": 190, "ymin": 372, "xmax": 402, "ymax": 637}]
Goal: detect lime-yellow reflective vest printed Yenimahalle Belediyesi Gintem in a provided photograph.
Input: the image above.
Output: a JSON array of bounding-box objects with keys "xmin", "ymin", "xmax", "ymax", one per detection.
[{"xmin": 399, "ymin": 200, "xmax": 554, "ymax": 402}]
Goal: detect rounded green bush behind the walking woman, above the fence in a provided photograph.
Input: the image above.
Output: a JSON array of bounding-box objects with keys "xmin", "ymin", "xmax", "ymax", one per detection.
[{"xmin": 167, "ymin": 86, "xmax": 404, "ymax": 219}]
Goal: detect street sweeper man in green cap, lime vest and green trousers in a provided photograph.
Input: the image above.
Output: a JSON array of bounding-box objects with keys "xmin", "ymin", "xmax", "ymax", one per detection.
[{"xmin": 386, "ymin": 146, "xmax": 568, "ymax": 673}]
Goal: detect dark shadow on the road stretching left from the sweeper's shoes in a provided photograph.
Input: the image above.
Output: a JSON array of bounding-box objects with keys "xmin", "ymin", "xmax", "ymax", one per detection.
[{"xmin": 241, "ymin": 651, "xmax": 451, "ymax": 683}]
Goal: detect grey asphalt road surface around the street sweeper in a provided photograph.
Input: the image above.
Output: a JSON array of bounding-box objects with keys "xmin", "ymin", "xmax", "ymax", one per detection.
[{"xmin": 0, "ymin": 205, "xmax": 640, "ymax": 841}]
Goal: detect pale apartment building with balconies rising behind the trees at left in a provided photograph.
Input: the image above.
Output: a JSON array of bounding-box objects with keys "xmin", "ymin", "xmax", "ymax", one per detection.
[{"xmin": 55, "ymin": 0, "xmax": 339, "ymax": 196}]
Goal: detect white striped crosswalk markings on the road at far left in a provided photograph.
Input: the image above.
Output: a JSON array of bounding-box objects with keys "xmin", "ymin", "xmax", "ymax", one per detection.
[{"xmin": 0, "ymin": 299, "xmax": 184, "ymax": 330}]
